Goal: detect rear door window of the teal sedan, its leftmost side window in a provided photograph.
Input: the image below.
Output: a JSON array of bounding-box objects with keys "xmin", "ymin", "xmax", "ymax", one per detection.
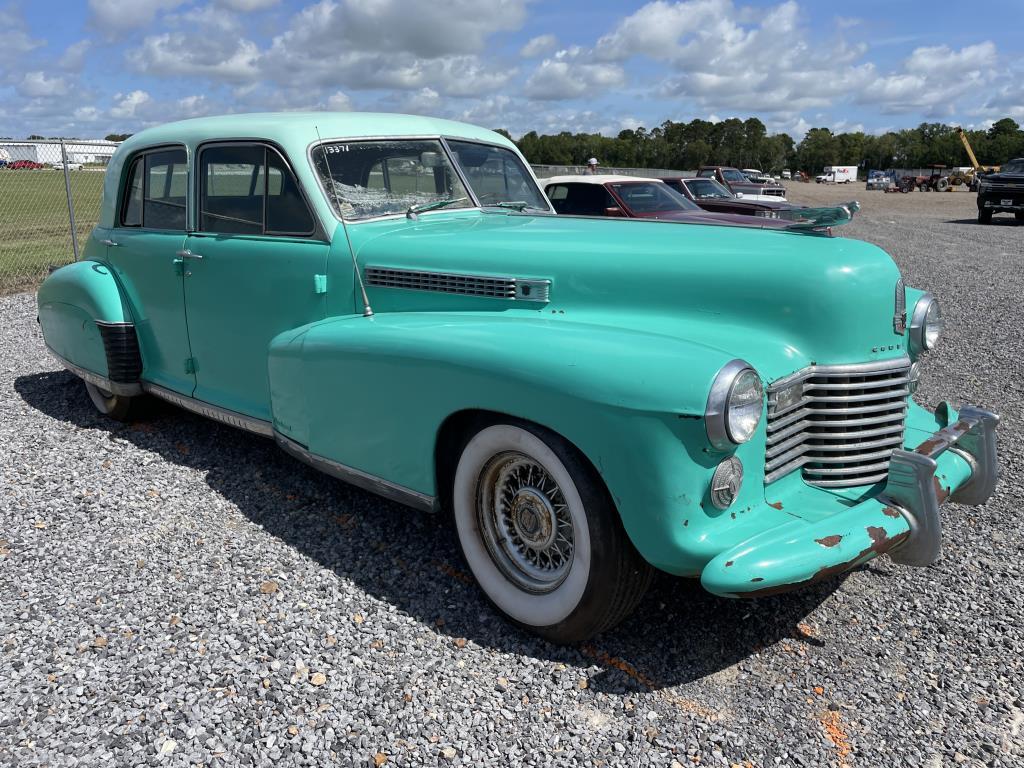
[{"xmin": 121, "ymin": 150, "xmax": 188, "ymax": 230}]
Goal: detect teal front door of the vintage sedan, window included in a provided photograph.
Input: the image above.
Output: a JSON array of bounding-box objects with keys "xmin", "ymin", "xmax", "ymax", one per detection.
[{"xmin": 183, "ymin": 142, "xmax": 329, "ymax": 421}]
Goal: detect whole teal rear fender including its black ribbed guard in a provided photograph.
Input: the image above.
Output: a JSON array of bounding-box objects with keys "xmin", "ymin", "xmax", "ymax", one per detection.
[{"xmin": 38, "ymin": 261, "xmax": 140, "ymax": 382}]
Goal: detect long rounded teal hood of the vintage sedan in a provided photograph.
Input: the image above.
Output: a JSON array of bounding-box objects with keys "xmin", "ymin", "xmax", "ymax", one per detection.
[{"xmin": 348, "ymin": 211, "xmax": 906, "ymax": 381}]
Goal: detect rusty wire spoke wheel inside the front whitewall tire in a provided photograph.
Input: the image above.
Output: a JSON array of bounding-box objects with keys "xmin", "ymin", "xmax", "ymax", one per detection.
[{"xmin": 476, "ymin": 451, "xmax": 574, "ymax": 594}]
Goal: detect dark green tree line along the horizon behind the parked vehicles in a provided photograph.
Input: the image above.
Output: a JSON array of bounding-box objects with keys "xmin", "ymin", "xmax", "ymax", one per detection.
[{"xmin": 499, "ymin": 118, "xmax": 1024, "ymax": 174}]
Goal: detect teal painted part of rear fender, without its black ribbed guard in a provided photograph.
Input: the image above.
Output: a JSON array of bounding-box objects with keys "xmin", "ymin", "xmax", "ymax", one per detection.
[{"xmin": 37, "ymin": 261, "xmax": 132, "ymax": 377}]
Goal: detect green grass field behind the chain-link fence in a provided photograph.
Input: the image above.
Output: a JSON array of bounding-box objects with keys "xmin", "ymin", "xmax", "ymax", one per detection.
[{"xmin": 0, "ymin": 169, "xmax": 104, "ymax": 295}]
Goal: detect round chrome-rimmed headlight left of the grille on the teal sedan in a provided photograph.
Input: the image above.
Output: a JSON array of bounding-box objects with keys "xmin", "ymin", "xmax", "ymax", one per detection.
[{"xmin": 705, "ymin": 359, "xmax": 764, "ymax": 451}]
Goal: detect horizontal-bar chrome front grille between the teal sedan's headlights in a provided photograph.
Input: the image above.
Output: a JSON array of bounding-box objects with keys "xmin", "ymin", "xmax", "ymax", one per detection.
[{"xmin": 765, "ymin": 357, "xmax": 910, "ymax": 487}]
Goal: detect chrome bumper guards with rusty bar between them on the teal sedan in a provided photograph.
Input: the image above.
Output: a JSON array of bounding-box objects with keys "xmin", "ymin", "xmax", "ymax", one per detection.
[{"xmin": 882, "ymin": 402, "xmax": 999, "ymax": 566}]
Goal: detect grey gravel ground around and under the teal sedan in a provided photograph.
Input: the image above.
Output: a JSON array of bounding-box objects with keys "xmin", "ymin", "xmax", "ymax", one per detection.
[{"xmin": 0, "ymin": 193, "xmax": 1024, "ymax": 768}]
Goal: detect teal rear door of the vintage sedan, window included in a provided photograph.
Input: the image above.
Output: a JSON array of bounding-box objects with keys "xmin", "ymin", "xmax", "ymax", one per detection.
[{"xmin": 98, "ymin": 146, "xmax": 196, "ymax": 394}]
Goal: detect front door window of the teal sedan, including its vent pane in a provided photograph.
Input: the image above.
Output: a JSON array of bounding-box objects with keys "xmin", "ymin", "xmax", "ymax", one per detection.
[{"xmin": 199, "ymin": 144, "xmax": 313, "ymax": 236}]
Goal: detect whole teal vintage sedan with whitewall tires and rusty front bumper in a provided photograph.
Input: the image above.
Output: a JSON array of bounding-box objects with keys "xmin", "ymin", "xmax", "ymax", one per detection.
[{"xmin": 39, "ymin": 114, "xmax": 998, "ymax": 642}]
